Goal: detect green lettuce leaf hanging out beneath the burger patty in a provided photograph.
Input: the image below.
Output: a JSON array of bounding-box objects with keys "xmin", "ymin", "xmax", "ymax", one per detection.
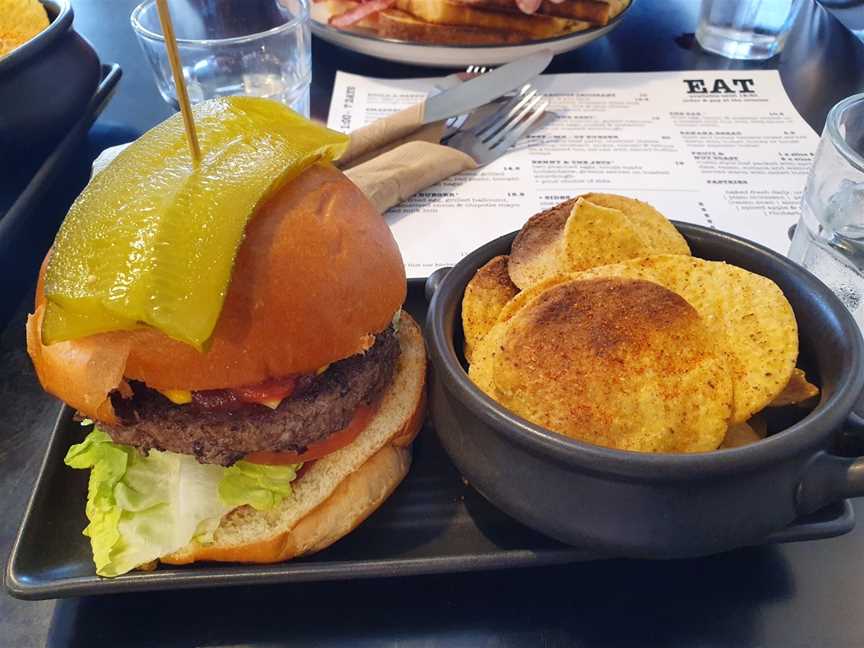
[{"xmin": 65, "ymin": 427, "xmax": 297, "ymax": 577}]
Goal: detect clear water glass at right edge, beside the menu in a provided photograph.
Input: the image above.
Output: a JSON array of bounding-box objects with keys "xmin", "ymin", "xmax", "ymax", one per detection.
[{"xmin": 789, "ymin": 94, "xmax": 864, "ymax": 328}]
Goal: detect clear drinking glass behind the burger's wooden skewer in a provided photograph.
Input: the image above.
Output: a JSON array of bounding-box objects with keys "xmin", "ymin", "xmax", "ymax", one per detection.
[{"xmin": 131, "ymin": 0, "xmax": 312, "ymax": 117}]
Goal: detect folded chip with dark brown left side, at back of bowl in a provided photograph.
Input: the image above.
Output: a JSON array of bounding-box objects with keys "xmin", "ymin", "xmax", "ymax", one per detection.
[{"xmin": 508, "ymin": 193, "xmax": 690, "ymax": 290}]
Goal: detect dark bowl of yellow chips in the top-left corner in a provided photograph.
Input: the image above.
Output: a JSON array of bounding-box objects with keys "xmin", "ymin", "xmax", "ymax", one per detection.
[{"xmin": 0, "ymin": 0, "xmax": 101, "ymax": 160}]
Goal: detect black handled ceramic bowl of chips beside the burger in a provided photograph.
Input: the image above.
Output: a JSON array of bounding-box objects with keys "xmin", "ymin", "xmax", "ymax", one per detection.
[{"xmin": 426, "ymin": 223, "xmax": 864, "ymax": 558}]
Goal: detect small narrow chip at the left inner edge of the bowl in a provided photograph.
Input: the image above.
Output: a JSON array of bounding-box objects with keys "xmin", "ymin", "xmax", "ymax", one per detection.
[{"xmin": 462, "ymin": 256, "xmax": 519, "ymax": 362}]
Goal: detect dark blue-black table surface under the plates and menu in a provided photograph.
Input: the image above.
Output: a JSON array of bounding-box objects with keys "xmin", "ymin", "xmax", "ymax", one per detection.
[{"xmin": 0, "ymin": 0, "xmax": 864, "ymax": 647}]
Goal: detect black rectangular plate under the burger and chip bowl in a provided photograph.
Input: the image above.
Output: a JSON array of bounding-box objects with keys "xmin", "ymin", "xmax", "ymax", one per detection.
[{"xmin": 6, "ymin": 280, "xmax": 855, "ymax": 599}]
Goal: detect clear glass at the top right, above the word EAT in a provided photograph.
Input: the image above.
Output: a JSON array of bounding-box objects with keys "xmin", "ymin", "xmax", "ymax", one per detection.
[{"xmin": 696, "ymin": 0, "xmax": 801, "ymax": 60}]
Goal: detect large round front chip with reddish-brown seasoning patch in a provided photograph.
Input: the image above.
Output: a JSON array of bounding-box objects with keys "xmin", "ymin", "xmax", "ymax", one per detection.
[{"xmin": 490, "ymin": 278, "xmax": 732, "ymax": 452}]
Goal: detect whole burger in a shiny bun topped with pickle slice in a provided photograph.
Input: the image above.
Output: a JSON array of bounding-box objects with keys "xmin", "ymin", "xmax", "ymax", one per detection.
[{"xmin": 27, "ymin": 97, "xmax": 426, "ymax": 576}]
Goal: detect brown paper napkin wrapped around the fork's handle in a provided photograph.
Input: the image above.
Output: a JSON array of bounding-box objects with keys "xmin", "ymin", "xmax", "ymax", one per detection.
[{"xmin": 345, "ymin": 141, "xmax": 477, "ymax": 214}]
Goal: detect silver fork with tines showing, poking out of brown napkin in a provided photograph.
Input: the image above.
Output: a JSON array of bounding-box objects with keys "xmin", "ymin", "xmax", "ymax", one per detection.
[{"xmin": 441, "ymin": 83, "xmax": 549, "ymax": 166}]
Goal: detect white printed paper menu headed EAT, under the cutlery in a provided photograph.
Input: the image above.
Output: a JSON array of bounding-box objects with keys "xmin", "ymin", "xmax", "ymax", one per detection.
[{"xmin": 328, "ymin": 70, "xmax": 818, "ymax": 277}]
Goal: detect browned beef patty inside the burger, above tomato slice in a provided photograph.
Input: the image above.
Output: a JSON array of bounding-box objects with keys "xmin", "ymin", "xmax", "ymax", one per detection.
[{"xmin": 100, "ymin": 328, "xmax": 399, "ymax": 466}]
